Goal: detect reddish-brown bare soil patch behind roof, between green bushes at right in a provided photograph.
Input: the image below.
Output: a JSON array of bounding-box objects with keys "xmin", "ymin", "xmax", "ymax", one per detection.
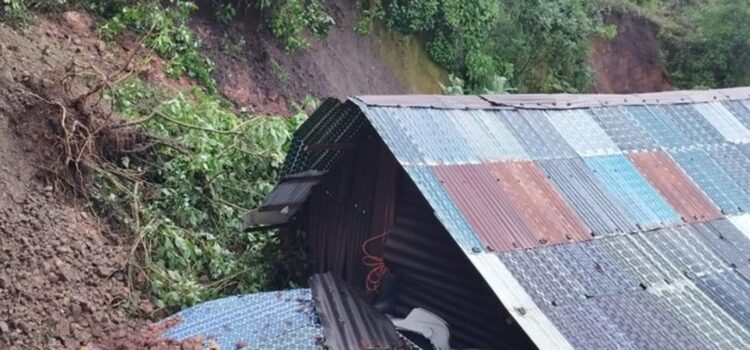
[{"xmin": 591, "ymin": 13, "xmax": 672, "ymax": 93}]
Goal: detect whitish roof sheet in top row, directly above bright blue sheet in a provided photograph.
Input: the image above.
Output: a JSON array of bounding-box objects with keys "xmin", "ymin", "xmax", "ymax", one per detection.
[{"xmin": 547, "ymin": 109, "xmax": 621, "ymax": 156}]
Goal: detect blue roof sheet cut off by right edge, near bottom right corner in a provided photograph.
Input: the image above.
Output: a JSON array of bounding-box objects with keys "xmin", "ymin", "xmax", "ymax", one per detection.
[{"xmin": 696, "ymin": 271, "xmax": 750, "ymax": 329}]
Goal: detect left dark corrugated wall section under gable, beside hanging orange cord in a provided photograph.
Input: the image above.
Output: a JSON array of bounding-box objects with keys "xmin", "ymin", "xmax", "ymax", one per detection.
[{"xmin": 308, "ymin": 130, "xmax": 397, "ymax": 287}]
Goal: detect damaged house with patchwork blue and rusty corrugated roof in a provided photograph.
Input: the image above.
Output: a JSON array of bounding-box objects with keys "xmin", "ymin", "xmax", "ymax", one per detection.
[{"xmin": 238, "ymin": 88, "xmax": 750, "ymax": 349}]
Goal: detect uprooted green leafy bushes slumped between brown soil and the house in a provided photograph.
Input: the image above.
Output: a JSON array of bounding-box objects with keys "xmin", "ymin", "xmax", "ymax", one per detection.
[{"xmin": 99, "ymin": 79, "xmax": 304, "ymax": 309}]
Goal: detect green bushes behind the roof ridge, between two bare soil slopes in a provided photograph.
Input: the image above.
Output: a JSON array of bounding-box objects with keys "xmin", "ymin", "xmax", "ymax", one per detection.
[{"xmin": 357, "ymin": 0, "xmax": 614, "ymax": 92}]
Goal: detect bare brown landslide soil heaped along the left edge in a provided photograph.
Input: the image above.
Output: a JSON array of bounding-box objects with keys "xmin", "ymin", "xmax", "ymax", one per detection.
[{"xmin": 0, "ymin": 12, "xmax": 166, "ymax": 349}]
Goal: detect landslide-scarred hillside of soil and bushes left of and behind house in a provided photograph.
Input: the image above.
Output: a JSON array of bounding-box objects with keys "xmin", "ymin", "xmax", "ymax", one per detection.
[{"xmin": 0, "ymin": 0, "xmax": 748, "ymax": 350}]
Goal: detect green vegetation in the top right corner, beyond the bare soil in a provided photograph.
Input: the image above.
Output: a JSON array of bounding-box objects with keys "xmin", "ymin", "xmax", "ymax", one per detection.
[{"xmin": 600, "ymin": 0, "xmax": 750, "ymax": 89}]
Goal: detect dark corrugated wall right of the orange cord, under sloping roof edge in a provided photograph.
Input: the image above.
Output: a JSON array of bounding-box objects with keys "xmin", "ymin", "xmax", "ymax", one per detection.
[{"xmin": 384, "ymin": 169, "xmax": 531, "ymax": 349}]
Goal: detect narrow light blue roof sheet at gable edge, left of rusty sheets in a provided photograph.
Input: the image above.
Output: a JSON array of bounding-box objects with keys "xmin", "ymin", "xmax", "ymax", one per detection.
[{"xmin": 404, "ymin": 166, "xmax": 485, "ymax": 253}]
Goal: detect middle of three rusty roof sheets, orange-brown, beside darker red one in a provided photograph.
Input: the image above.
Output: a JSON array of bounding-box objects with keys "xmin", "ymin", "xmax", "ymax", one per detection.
[{"xmin": 486, "ymin": 161, "xmax": 591, "ymax": 244}]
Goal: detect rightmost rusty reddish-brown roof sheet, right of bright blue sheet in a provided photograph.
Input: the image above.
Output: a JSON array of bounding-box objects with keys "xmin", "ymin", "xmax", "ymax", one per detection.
[{"xmin": 628, "ymin": 151, "xmax": 722, "ymax": 223}]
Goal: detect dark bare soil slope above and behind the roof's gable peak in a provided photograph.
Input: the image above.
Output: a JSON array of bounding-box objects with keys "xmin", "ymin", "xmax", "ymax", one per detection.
[{"xmin": 193, "ymin": 0, "xmax": 420, "ymax": 114}]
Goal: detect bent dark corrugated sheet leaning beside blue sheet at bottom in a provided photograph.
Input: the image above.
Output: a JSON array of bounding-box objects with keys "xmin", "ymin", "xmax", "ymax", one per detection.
[{"xmin": 310, "ymin": 273, "xmax": 407, "ymax": 350}]
